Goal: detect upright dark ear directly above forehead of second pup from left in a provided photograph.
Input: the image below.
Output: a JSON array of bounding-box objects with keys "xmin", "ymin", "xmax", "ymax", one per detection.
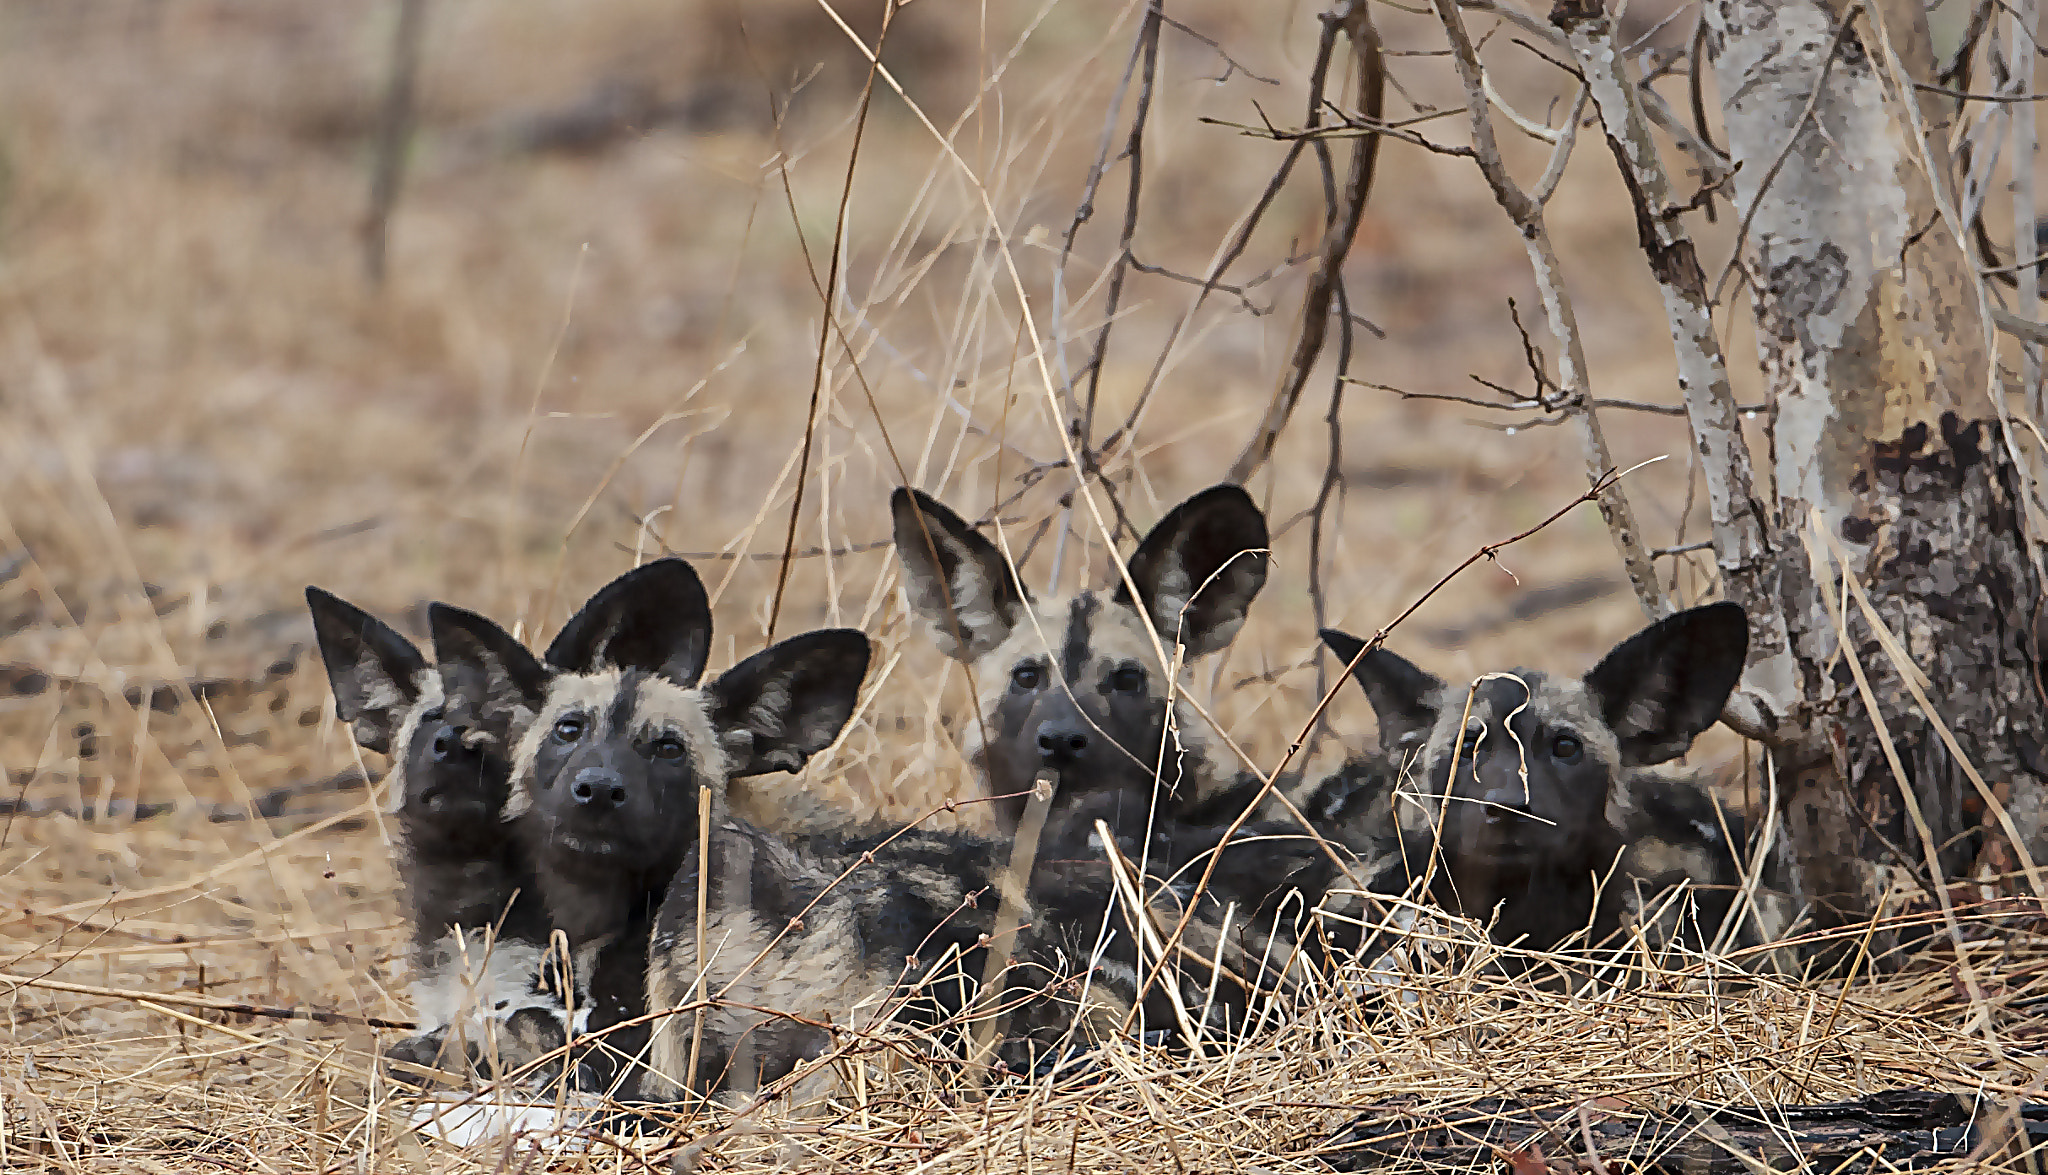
[{"xmin": 547, "ymin": 559, "xmax": 711, "ymax": 688}]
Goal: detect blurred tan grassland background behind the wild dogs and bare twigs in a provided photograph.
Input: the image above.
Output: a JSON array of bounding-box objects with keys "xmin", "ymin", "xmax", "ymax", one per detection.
[{"xmin": 0, "ymin": 0, "xmax": 1826, "ymax": 1162}]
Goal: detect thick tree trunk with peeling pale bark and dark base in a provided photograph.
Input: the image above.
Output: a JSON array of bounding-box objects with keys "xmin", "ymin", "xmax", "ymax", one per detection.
[{"xmin": 1706, "ymin": 0, "xmax": 2048, "ymax": 949}]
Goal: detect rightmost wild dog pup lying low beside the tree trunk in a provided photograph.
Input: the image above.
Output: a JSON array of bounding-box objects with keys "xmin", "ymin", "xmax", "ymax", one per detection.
[{"xmin": 1323, "ymin": 604, "xmax": 1780, "ymax": 950}]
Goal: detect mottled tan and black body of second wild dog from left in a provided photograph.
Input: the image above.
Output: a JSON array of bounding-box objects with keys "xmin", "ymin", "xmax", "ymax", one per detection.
[{"xmin": 649, "ymin": 821, "xmax": 1212, "ymax": 1101}]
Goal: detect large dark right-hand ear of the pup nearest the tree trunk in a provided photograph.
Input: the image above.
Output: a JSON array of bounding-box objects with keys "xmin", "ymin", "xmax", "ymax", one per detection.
[{"xmin": 1585, "ymin": 604, "xmax": 1749, "ymax": 766}]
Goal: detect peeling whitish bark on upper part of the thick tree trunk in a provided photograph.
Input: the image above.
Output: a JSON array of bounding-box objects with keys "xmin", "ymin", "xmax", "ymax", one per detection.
[{"xmin": 1706, "ymin": 0, "xmax": 1985, "ymax": 679}]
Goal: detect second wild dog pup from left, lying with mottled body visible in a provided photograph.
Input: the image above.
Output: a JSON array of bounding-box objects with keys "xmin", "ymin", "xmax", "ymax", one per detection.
[{"xmin": 436, "ymin": 581, "xmax": 1231, "ymax": 1097}]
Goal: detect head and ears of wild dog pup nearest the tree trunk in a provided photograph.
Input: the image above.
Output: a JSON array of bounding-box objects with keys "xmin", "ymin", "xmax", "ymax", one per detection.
[{"xmin": 1323, "ymin": 604, "xmax": 1749, "ymax": 874}]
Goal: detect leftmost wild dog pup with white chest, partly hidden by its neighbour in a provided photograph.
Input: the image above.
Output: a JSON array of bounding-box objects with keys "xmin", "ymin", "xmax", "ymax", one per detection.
[{"xmin": 305, "ymin": 588, "xmax": 567, "ymax": 1079}]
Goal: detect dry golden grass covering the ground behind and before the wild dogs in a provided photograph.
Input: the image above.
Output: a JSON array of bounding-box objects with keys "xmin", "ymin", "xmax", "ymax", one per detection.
[{"xmin": 0, "ymin": 0, "xmax": 2034, "ymax": 1171}]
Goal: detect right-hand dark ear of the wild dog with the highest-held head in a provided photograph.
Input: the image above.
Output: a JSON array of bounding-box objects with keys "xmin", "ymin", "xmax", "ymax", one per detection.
[{"xmin": 1116, "ymin": 485, "xmax": 1266, "ymax": 657}]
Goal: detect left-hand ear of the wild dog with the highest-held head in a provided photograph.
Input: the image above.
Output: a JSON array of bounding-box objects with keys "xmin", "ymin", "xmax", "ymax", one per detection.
[{"xmin": 889, "ymin": 485, "xmax": 1026, "ymax": 661}]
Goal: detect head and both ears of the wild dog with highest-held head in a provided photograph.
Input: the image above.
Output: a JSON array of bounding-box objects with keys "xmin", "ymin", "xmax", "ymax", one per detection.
[{"xmin": 891, "ymin": 485, "xmax": 1266, "ymax": 833}]
